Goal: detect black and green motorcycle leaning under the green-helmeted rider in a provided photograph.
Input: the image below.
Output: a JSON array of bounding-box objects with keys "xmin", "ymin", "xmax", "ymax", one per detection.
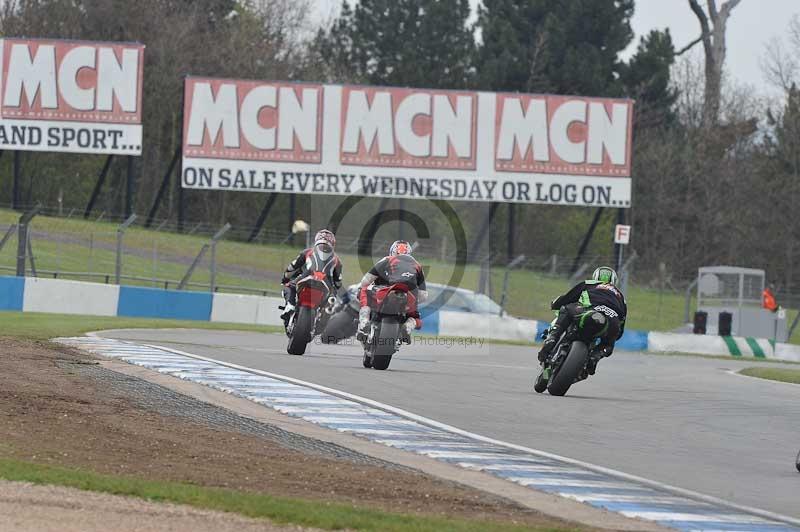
[{"xmin": 533, "ymin": 310, "xmax": 608, "ymax": 396}]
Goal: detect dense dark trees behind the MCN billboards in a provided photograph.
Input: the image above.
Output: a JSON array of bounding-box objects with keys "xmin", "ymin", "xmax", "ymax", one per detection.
[{"xmin": 0, "ymin": 0, "xmax": 800, "ymax": 289}]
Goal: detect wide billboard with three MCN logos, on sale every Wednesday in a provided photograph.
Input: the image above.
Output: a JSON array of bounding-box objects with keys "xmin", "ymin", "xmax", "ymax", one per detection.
[{"xmin": 182, "ymin": 77, "xmax": 633, "ymax": 207}]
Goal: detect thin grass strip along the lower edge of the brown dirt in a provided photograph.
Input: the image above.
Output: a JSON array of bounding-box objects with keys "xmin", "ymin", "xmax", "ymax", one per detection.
[{"xmin": 0, "ymin": 458, "xmax": 567, "ymax": 532}]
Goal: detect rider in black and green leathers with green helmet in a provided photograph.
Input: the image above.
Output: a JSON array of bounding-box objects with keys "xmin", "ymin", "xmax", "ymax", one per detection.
[{"xmin": 539, "ymin": 266, "xmax": 628, "ymax": 375}]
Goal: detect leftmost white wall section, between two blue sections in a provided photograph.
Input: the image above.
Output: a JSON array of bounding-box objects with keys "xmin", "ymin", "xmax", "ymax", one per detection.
[{"xmin": 22, "ymin": 277, "xmax": 119, "ymax": 316}]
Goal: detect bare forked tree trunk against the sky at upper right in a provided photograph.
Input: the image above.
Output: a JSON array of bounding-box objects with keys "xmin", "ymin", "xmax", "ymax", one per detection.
[{"xmin": 678, "ymin": 0, "xmax": 741, "ymax": 128}]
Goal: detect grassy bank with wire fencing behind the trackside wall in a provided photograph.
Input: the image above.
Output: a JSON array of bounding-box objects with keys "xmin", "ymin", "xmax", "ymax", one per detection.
[{"xmin": 0, "ymin": 204, "xmax": 800, "ymax": 328}]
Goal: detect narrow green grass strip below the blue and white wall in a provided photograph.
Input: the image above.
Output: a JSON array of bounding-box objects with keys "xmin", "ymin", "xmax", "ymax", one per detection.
[{"xmin": 0, "ymin": 312, "xmax": 282, "ymax": 340}]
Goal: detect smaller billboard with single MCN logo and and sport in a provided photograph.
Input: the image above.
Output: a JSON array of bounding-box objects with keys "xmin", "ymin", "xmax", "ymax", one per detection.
[{"xmin": 0, "ymin": 39, "xmax": 144, "ymax": 155}]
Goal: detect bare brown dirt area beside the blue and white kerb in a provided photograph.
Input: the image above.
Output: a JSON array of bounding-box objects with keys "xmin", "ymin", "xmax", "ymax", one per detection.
[{"xmin": 0, "ymin": 338, "xmax": 588, "ymax": 527}]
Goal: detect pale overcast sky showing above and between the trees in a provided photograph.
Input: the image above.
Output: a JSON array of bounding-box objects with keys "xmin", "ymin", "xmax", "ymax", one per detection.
[{"xmin": 316, "ymin": 0, "xmax": 800, "ymax": 91}]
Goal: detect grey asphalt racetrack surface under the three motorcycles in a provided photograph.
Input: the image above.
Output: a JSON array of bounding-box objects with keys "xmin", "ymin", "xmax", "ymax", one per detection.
[{"xmin": 103, "ymin": 330, "xmax": 800, "ymax": 518}]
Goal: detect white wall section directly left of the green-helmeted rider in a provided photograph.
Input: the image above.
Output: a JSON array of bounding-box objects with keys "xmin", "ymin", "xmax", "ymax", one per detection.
[{"xmin": 439, "ymin": 311, "xmax": 536, "ymax": 342}]
